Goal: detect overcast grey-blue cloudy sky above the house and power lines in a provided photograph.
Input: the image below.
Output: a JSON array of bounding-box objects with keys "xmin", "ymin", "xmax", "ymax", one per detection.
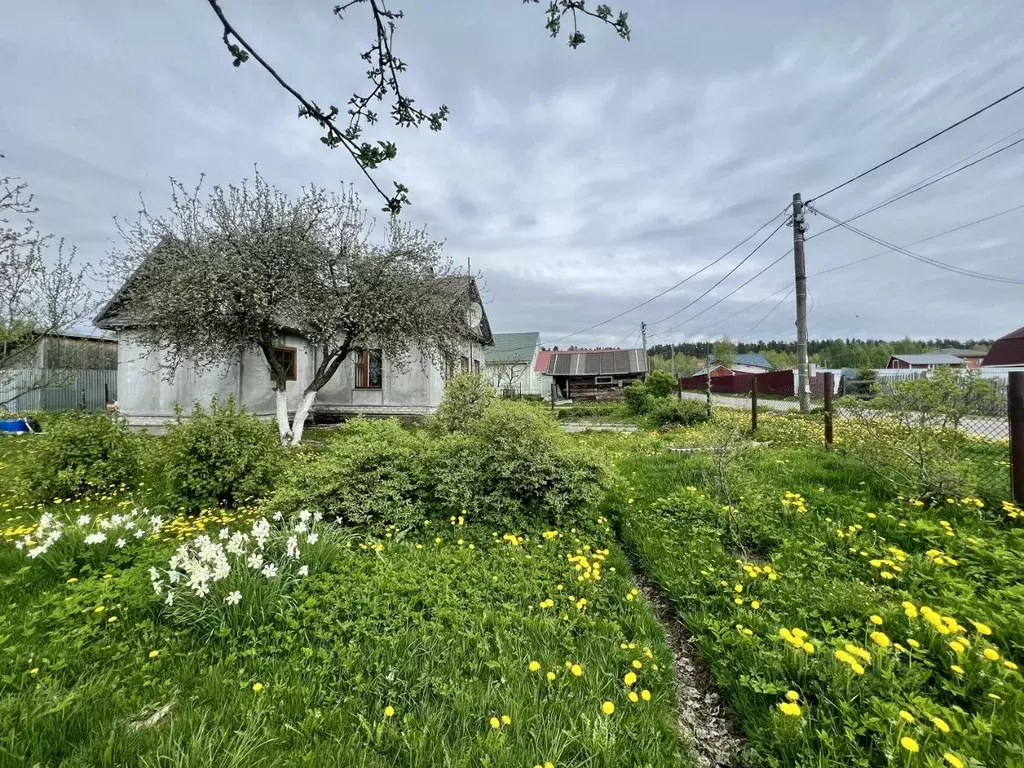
[{"xmin": 0, "ymin": 0, "xmax": 1024, "ymax": 345}]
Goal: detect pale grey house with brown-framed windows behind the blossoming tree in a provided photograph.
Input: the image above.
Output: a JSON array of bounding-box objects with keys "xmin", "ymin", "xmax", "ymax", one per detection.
[{"xmin": 94, "ymin": 278, "xmax": 493, "ymax": 428}]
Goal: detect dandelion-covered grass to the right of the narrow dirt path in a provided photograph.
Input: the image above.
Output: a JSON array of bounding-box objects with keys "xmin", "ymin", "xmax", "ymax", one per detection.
[{"xmin": 587, "ymin": 419, "xmax": 1024, "ymax": 768}]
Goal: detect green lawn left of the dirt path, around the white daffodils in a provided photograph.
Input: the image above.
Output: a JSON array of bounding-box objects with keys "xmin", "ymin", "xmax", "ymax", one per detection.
[{"xmin": 0, "ymin": 505, "xmax": 689, "ymax": 768}]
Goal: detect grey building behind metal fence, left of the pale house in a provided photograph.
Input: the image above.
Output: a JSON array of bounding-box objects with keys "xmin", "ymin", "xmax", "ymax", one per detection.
[{"xmin": 0, "ymin": 331, "xmax": 118, "ymax": 412}]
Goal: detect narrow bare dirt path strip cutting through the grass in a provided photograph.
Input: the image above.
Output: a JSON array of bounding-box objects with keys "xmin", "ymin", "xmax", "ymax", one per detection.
[{"xmin": 633, "ymin": 568, "xmax": 742, "ymax": 768}]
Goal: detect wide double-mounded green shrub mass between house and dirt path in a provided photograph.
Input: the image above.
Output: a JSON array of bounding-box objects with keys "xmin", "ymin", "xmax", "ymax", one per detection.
[{"xmin": 284, "ymin": 399, "xmax": 607, "ymax": 530}]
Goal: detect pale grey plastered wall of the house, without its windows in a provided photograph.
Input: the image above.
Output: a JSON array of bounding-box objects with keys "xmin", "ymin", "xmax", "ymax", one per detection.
[{"xmin": 118, "ymin": 332, "xmax": 483, "ymax": 428}]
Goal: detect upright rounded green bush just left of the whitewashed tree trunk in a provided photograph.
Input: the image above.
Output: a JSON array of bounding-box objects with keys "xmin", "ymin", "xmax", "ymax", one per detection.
[{"xmin": 161, "ymin": 397, "xmax": 284, "ymax": 510}]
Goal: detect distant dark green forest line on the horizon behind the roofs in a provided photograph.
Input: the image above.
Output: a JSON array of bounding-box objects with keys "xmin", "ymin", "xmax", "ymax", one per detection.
[{"xmin": 648, "ymin": 338, "xmax": 992, "ymax": 375}]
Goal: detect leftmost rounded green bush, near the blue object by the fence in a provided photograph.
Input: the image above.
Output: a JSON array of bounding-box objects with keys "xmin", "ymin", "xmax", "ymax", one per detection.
[{"xmin": 20, "ymin": 414, "xmax": 138, "ymax": 502}]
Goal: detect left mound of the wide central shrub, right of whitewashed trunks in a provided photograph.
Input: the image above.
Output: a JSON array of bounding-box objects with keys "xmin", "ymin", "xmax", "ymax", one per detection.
[{"xmin": 273, "ymin": 418, "xmax": 425, "ymax": 525}]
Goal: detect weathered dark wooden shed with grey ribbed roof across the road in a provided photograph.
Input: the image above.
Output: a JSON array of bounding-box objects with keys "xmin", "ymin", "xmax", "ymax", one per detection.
[{"xmin": 545, "ymin": 349, "xmax": 649, "ymax": 400}]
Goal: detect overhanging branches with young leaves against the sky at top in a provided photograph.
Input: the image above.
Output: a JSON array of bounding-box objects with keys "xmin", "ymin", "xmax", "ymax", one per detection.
[{"xmin": 207, "ymin": 0, "xmax": 630, "ymax": 214}]
